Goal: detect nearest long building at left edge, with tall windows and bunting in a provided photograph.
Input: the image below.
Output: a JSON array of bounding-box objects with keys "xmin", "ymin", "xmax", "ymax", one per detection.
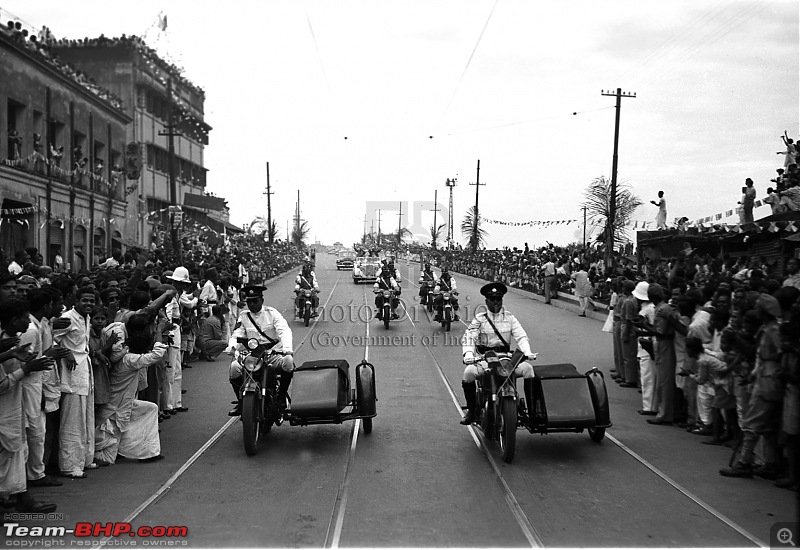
[{"xmin": 0, "ymin": 22, "xmax": 130, "ymax": 269}]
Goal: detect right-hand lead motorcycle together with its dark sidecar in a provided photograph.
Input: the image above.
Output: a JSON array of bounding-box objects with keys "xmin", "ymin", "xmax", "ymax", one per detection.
[{"xmin": 462, "ymin": 350, "xmax": 611, "ymax": 462}]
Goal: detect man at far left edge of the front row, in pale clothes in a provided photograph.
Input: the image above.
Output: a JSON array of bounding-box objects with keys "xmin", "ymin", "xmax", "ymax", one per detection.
[{"xmin": 0, "ymin": 298, "xmax": 56, "ymax": 513}]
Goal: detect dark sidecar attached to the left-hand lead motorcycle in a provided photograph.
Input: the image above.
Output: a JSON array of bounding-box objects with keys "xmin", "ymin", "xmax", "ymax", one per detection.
[{"xmin": 284, "ymin": 359, "xmax": 378, "ymax": 434}]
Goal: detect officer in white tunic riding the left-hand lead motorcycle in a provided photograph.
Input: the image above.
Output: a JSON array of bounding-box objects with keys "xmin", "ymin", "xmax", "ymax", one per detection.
[{"xmin": 225, "ymin": 285, "xmax": 294, "ymax": 416}]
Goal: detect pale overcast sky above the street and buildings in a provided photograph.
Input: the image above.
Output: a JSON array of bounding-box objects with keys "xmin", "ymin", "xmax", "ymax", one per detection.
[{"xmin": 0, "ymin": 0, "xmax": 800, "ymax": 247}]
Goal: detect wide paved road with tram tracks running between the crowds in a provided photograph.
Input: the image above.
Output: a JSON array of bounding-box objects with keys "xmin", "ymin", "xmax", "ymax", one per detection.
[{"xmin": 15, "ymin": 254, "xmax": 795, "ymax": 547}]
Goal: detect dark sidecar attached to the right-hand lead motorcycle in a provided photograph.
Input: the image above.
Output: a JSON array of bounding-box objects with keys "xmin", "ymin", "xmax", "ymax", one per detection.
[{"xmin": 521, "ymin": 363, "xmax": 611, "ymax": 442}]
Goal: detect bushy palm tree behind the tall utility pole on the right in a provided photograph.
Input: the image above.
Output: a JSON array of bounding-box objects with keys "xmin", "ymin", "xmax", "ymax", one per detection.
[{"xmin": 581, "ymin": 176, "xmax": 643, "ymax": 266}]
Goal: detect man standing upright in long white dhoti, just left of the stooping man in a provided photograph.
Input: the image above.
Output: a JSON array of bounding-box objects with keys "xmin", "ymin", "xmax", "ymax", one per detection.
[{"xmin": 53, "ymin": 288, "xmax": 97, "ymax": 479}]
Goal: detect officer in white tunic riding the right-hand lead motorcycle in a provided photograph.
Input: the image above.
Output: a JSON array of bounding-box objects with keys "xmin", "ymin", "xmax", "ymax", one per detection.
[{"xmin": 461, "ymin": 283, "xmax": 536, "ymax": 426}]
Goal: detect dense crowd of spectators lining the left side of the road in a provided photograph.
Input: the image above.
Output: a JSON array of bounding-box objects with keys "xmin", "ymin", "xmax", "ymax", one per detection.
[{"xmin": 0, "ymin": 235, "xmax": 304, "ymax": 513}]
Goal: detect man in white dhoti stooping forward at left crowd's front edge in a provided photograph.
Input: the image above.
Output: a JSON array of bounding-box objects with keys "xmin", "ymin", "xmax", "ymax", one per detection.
[{"xmin": 95, "ymin": 313, "xmax": 167, "ymax": 464}]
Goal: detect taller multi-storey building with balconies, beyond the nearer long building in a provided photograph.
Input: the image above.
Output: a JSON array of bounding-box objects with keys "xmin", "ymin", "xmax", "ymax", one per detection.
[{"xmin": 55, "ymin": 36, "xmax": 216, "ymax": 250}]
